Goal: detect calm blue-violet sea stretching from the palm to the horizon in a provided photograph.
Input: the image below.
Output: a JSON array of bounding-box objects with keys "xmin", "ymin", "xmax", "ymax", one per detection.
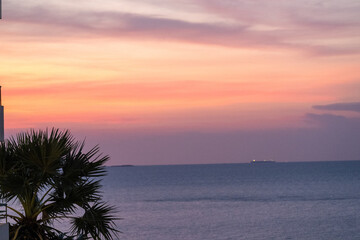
[{"xmin": 103, "ymin": 161, "xmax": 360, "ymax": 240}]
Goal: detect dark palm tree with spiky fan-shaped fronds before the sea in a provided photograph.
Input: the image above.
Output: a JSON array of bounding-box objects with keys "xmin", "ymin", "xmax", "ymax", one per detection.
[{"xmin": 0, "ymin": 129, "xmax": 119, "ymax": 240}]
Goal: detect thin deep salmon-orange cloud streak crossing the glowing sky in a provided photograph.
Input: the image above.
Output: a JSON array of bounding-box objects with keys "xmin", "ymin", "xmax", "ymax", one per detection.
[{"xmin": 6, "ymin": 81, "xmax": 334, "ymax": 106}]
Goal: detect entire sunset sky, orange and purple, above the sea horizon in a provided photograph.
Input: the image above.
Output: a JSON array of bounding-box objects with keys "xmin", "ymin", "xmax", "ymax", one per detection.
[{"xmin": 0, "ymin": 0, "xmax": 360, "ymax": 165}]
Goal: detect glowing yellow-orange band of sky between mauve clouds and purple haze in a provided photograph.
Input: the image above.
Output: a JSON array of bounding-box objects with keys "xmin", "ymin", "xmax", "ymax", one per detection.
[{"xmin": 0, "ymin": 36, "xmax": 359, "ymax": 128}]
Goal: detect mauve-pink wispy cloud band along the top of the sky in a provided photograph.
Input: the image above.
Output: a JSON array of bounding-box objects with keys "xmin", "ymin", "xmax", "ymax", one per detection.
[{"xmin": 6, "ymin": 0, "xmax": 360, "ymax": 55}]
